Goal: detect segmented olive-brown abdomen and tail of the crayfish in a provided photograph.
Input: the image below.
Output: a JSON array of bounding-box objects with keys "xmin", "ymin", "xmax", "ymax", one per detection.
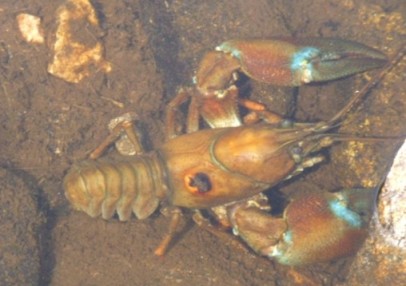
[{"xmin": 64, "ymin": 156, "xmax": 166, "ymax": 221}]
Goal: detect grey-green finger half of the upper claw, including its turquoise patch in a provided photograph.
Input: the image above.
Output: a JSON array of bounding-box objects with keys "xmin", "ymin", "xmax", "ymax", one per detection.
[{"xmin": 291, "ymin": 38, "xmax": 387, "ymax": 83}]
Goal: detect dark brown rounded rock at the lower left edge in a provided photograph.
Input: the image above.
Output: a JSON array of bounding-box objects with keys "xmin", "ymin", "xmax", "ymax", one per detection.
[{"xmin": 0, "ymin": 168, "xmax": 44, "ymax": 285}]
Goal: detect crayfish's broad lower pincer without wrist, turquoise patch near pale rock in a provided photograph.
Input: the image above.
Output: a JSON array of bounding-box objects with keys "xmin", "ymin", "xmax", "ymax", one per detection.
[{"xmin": 268, "ymin": 189, "xmax": 376, "ymax": 265}]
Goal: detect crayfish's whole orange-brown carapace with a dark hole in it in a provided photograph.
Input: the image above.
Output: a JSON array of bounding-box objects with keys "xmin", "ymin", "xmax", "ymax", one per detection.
[{"xmin": 160, "ymin": 124, "xmax": 326, "ymax": 208}]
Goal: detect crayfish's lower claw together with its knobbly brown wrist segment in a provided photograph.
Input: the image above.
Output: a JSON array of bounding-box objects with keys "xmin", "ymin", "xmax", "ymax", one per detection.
[{"xmin": 230, "ymin": 189, "xmax": 376, "ymax": 265}]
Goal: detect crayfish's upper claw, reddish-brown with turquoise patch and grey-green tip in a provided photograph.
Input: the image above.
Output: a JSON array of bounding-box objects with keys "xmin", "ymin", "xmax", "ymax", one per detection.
[{"xmin": 216, "ymin": 38, "xmax": 387, "ymax": 86}]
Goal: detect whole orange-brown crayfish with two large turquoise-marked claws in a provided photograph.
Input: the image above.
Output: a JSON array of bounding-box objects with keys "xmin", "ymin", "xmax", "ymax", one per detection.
[{"xmin": 64, "ymin": 36, "xmax": 405, "ymax": 265}]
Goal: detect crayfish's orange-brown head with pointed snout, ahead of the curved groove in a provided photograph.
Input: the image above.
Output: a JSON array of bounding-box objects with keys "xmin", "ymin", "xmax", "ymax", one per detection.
[{"xmin": 212, "ymin": 124, "xmax": 334, "ymax": 183}]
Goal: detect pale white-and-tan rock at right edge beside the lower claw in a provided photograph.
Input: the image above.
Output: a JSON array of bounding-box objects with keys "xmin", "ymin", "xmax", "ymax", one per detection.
[{"xmin": 346, "ymin": 141, "xmax": 406, "ymax": 286}]
